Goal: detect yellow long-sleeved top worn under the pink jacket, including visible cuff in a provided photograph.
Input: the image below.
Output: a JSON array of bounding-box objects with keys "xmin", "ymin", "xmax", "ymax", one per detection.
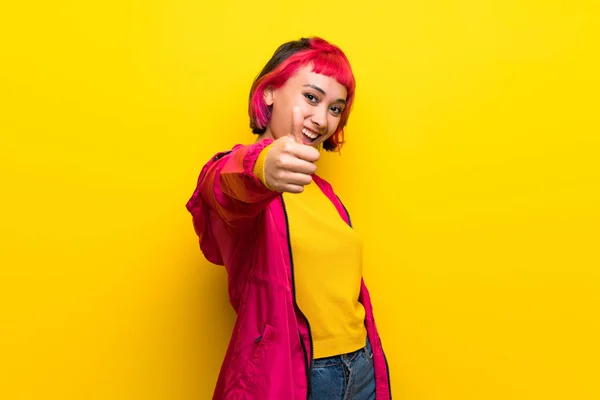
[{"xmin": 254, "ymin": 147, "xmax": 367, "ymax": 358}]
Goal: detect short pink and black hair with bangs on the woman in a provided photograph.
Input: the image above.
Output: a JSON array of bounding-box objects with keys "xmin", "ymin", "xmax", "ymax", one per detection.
[{"xmin": 248, "ymin": 37, "xmax": 356, "ymax": 151}]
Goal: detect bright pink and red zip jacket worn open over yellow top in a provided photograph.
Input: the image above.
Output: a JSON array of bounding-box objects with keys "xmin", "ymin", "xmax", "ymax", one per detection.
[{"xmin": 187, "ymin": 140, "xmax": 391, "ymax": 400}]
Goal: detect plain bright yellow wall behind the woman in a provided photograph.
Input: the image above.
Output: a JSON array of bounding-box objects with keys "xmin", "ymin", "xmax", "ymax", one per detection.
[{"xmin": 0, "ymin": 0, "xmax": 600, "ymax": 400}]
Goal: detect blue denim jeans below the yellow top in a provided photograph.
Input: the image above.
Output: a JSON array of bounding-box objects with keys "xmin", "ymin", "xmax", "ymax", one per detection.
[{"xmin": 310, "ymin": 339, "xmax": 375, "ymax": 400}]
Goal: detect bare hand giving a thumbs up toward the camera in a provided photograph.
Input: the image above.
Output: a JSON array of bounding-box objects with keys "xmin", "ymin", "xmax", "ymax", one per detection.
[{"xmin": 265, "ymin": 107, "xmax": 320, "ymax": 193}]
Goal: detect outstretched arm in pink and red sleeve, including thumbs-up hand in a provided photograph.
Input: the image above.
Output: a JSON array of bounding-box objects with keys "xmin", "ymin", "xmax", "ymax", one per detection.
[{"xmin": 187, "ymin": 107, "xmax": 319, "ymax": 225}]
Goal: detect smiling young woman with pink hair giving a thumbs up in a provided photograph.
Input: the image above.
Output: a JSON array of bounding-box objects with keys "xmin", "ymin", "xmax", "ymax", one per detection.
[{"xmin": 187, "ymin": 37, "xmax": 391, "ymax": 400}]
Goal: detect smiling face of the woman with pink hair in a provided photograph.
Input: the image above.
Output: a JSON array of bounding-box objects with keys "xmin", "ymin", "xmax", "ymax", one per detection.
[{"xmin": 263, "ymin": 65, "xmax": 347, "ymax": 145}]
